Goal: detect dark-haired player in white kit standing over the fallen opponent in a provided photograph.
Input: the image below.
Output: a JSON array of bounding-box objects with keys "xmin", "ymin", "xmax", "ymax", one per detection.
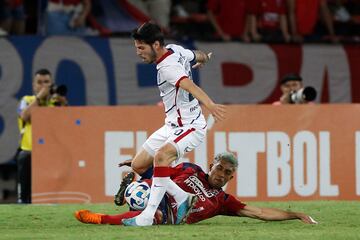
[{"xmin": 117, "ymin": 22, "xmax": 225, "ymax": 226}]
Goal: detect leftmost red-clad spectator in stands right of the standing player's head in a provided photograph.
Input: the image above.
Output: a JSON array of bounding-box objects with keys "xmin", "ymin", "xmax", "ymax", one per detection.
[{"xmin": 207, "ymin": 0, "xmax": 250, "ymax": 42}]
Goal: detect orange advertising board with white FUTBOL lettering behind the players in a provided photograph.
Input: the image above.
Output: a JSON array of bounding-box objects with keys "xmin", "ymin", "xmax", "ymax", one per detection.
[{"xmin": 32, "ymin": 104, "xmax": 360, "ymax": 203}]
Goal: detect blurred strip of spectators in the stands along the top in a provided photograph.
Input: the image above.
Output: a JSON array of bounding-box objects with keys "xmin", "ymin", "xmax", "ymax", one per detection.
[{"xmin": 0, "ymin": 0, "xmax": 360, "ymax": 43}]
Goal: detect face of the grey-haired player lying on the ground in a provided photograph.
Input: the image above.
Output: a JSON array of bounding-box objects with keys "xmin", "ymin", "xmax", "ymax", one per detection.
[{"xmin": 209, "ymin": 160, "xmax": 235, "ymax": 188}]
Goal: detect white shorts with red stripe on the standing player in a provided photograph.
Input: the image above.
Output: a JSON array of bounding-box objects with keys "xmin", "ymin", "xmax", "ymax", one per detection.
[{"xmin": 143, "ymin": 125, "xmax": 206, "ymax": 159}]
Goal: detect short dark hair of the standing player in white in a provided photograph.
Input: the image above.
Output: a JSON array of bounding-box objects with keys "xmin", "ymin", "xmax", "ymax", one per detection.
[{"xmin": 131, "ymin": 22, "xmax": 165, "ymax": 46}]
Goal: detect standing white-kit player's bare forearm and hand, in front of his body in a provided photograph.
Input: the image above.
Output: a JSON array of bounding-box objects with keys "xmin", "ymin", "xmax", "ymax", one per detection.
[{"xmin": 180, "ymin": 78, "xmax": 226, "ymax": 122}]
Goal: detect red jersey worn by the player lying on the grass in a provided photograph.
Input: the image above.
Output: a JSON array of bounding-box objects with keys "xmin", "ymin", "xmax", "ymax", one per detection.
[{"xmin": 171, "ymin": 163, "xmax": 246, "ymax": 224}]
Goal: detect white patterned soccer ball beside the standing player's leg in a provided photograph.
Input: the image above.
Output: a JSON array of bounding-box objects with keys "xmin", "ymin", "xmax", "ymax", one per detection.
[{"xmin": 125, "ymin": 181, "xmax": 150, "ymax": 210}]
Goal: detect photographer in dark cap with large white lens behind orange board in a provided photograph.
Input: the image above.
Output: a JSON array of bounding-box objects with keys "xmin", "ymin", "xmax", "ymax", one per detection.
[{"xmin": 273, "ymin": 73, "xmax": 317, "ymax": 105}]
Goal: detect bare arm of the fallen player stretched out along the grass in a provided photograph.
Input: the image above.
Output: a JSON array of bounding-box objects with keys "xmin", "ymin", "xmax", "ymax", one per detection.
[{"xmin": 238, "ymin": 205, "xmax": 317, "ymax": 224}]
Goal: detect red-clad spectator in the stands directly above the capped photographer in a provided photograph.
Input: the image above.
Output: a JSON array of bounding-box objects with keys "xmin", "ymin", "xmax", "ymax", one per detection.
[{"xmin": 287, "ymin": 0, "xmax": 339, "ymax": 43}]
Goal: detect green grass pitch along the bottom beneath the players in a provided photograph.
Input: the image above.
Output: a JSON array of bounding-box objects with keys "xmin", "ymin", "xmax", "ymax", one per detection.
[{"xmin": 0, "ymin": 201, "xmax": 360, "ymax": 240}]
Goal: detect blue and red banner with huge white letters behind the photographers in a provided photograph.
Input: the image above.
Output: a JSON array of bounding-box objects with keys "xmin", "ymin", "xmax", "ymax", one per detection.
[{"xmin": 0, "ymin": 36, "xmax": 360, "ymax": 163}]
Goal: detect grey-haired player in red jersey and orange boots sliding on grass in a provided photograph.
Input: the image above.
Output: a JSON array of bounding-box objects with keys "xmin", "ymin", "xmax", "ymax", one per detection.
[{"xmin": 75, "ymin": 152, "xmax": 317, "ymax": 225}]
